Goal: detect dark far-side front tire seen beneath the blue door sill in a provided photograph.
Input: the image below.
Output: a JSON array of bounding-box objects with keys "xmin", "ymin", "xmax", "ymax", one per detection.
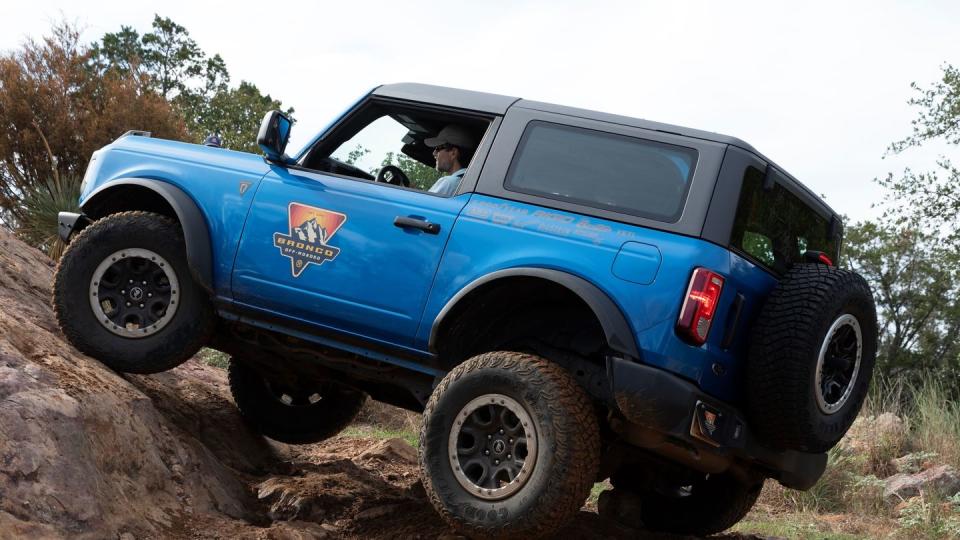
[{"xmin": 228, "ymin": 358, "xmax": 367, "ymax": 444}]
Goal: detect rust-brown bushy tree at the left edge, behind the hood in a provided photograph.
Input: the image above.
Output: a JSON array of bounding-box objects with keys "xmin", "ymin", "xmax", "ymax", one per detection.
[{"xmin": 0, "ymin": 23, "xmax": 187, "ymax": 227}]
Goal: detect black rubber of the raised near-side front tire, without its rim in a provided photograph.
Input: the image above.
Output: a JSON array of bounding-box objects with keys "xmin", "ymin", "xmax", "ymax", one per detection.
[{"xmin": 53, "ymin": 212, "xmax": 215, "ymax": 373}]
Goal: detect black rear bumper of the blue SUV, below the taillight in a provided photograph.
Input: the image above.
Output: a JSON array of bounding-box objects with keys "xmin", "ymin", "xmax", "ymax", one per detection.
[{"xmin": 607, "ymin": 358, "xmax": 827, "ymax": 490}]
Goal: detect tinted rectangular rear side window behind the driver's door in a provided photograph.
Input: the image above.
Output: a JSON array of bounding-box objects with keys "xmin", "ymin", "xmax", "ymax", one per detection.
[{"xmin": 504, "ymin": 122, "xmax": 697, "ymax": 223}]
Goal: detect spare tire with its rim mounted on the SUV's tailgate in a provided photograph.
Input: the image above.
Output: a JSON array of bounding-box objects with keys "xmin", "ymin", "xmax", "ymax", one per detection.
[{"xmin": 746, "ymin": 264, "xmax": 877, "ymax": 452}]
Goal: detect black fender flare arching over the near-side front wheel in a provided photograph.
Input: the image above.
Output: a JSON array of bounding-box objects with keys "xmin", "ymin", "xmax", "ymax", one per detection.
[{"xmin": 81, "ymin": 178, "xmax": 213, "ymax": 293}]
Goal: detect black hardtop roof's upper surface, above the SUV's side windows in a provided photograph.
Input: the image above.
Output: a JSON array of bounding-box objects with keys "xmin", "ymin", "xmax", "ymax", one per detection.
[{"xmin": 372, "ymin": 83, "xmax": 839, "ymax": 217}]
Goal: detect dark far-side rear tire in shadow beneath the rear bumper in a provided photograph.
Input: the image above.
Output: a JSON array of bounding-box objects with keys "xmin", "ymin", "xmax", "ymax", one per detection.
[{"xmin": 632, "ymin": 474, "xmax": 763, "ymax": 536}]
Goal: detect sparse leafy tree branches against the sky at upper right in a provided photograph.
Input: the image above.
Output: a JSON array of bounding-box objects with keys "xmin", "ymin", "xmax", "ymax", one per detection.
[{"xmin": 878, "ymin": 64, "xmax": 960, "ymax": 243}]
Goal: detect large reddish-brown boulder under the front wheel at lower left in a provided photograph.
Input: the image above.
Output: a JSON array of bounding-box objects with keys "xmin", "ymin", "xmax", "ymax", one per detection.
[{"xmin": 0, "ymin": 231, "xmax": 264, "ymax": 538}]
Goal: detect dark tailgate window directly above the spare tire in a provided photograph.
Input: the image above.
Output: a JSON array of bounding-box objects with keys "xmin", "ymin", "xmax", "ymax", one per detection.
[{"xmin": 731, "ymin": 167, "xmax": 839, "ymax": 274}]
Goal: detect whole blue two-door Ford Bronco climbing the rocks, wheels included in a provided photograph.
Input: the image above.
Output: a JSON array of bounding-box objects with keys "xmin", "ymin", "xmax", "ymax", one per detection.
[{"xmin": 53, "ymin": 84, "xmax": 877, "ymax": 537}]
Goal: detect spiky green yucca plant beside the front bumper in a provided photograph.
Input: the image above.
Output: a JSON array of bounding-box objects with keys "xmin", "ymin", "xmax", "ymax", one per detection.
[{"xmin": 16, "ymin": 175, "xmax": 81, "ymax": 260}]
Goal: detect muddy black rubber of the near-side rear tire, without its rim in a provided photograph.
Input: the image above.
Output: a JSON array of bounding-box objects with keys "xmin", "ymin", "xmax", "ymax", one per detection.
[{"xmin": 419, "ymin": 351, "xmax": 600, "ymax": 538}]
